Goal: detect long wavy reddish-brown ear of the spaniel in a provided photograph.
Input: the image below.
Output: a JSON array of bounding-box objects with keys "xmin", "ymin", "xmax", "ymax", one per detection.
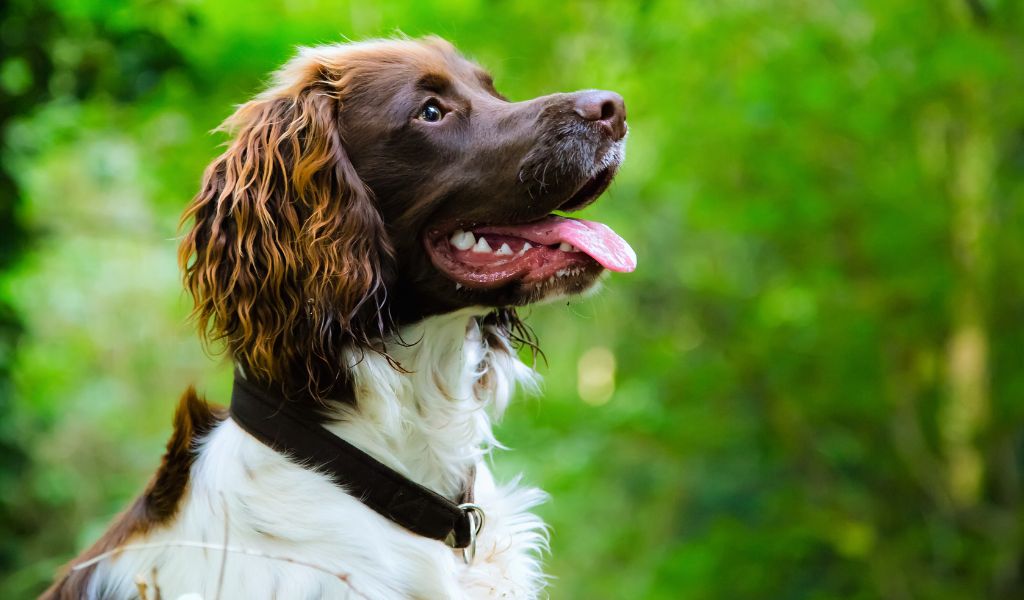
[{"xmin": 178, "ymin": 59, "xmax": 390, "ymax": 391}]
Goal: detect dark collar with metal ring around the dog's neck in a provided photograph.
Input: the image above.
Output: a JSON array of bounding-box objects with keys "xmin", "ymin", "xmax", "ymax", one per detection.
[{"xmin": 230, "ymin": 374, "xmax": 480, "ymax": 549}]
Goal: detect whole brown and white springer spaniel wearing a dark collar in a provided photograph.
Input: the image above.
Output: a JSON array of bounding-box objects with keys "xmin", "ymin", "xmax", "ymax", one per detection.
[{"xmin": 44, "ymin": 38, "xmax": 636, "ymax": 600}]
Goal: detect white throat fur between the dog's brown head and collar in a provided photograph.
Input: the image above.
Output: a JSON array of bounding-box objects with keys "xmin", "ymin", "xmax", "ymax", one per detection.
[{"xmin": 326, "ymin": 309, "xmax": 536, "ymax": 498}]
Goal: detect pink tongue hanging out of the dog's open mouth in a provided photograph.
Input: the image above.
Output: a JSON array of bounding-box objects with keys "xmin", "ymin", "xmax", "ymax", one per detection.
[{"xmin": 509, "ymin": 215, "xmax": 637, "ymax": 273}]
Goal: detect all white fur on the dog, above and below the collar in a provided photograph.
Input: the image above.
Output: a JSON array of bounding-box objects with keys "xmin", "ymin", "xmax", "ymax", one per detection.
[{"xmin": 90, "ymin": 311, "xmax": 547, "ymax": 600}]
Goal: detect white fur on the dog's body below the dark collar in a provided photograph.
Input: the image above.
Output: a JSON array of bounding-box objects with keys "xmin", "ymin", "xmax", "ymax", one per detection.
[{"xmin": 94, "ymin": 421, "xmax": 546, "ymax": 600}]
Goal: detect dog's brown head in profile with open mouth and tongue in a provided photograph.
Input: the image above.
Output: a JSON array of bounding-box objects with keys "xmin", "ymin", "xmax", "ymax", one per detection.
[{"xmin": 179, "ymin": 38, "xmax": 635, "ymax": 389}]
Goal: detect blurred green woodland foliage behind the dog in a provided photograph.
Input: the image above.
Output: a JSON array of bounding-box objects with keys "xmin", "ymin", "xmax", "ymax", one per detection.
[{"xmin": 0, "ymin": 0, "xmax": 1024, "ymax": 600}]
